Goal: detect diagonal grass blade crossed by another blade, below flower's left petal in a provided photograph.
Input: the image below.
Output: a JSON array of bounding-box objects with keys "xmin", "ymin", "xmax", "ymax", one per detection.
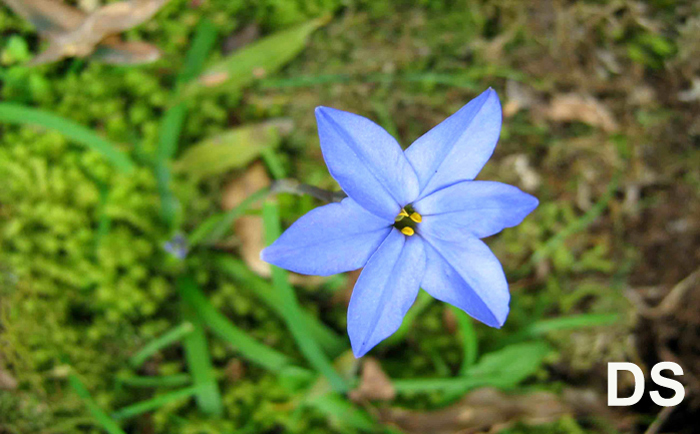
[{"xmin": 215, "ymin": 255, "xmax": 348, "ymax": 357}]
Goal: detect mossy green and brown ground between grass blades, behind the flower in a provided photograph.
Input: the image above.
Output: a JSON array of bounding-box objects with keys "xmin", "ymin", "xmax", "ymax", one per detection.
[{"xmin": 0, "ymin": 0, "xmax": 700, "ymax": 434}]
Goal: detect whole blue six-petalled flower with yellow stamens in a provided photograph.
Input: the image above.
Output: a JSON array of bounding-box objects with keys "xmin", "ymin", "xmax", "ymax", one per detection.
[{"xmin": 261, "ymin": 89, "xmax": 538, "ymax": 357}]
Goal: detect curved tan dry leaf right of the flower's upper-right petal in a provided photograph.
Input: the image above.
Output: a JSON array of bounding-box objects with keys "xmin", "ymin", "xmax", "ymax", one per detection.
[{"xmin": 545, "ymin": 93, "xmax": 618, "ymax": 132}]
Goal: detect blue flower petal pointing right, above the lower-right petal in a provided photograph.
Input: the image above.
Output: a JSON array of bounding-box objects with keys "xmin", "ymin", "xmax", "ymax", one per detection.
[{"xmin": 413, "ymin": 181, "xmax": 539, "ymax": 240}]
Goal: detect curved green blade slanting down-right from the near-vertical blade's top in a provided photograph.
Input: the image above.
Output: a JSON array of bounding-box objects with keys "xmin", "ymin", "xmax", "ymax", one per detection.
[{"xmin": 178, "ymin": 277, "xmax": 292, "ymax": 372}]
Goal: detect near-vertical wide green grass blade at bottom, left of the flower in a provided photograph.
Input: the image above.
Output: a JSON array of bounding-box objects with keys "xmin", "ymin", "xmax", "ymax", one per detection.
[{"xmin": 178, "ymin": 282, "xmax": 224, "ymax": 417}]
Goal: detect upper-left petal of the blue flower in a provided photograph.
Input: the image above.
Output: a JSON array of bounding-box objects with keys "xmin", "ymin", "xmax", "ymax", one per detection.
[{"xmin": 316, "ymin": 107, "xmax": 418, "ymax": 219}]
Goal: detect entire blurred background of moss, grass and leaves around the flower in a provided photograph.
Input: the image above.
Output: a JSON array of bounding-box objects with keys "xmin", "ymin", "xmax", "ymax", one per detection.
[{"xmin": 0, "ymin": 0, "xmax": 700, "ymax": 434}]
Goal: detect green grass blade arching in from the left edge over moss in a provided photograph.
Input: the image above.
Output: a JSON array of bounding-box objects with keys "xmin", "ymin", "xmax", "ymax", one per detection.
[{"xmin": 0, "ymin": 102, "xmax": 135, "ymax": 173}]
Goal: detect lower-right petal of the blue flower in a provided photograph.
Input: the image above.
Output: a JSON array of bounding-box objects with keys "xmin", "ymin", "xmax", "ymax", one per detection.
[{"xmin": 421, "ymin": 237, "xmax": 510, "ymax": 328}]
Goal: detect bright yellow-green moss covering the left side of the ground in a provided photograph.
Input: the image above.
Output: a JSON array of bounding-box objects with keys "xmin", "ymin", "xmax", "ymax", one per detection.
[{"xmin": 0, "ymin": 1, "xmax": 344, "ymax": 432}]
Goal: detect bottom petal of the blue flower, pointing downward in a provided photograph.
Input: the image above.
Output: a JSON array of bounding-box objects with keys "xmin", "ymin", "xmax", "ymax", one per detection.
[{"xmin": 348, "ymin": 230, "xmax": 425, "ymax": 357}]
